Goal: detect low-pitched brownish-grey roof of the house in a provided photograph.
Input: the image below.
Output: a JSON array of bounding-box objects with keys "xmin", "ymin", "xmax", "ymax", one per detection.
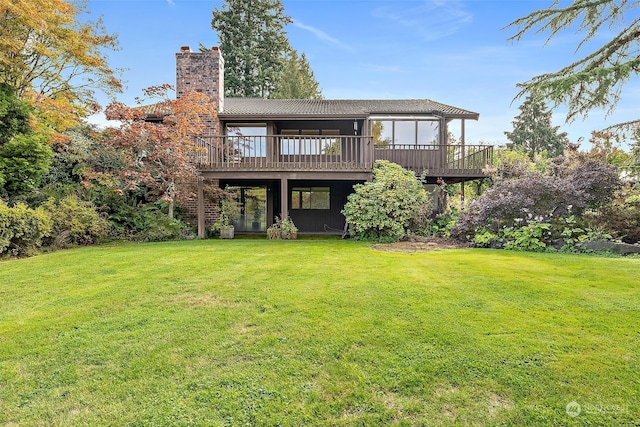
[{"xmin": 218, "ymin": 98, "xmax": 478, "ymax": 120}]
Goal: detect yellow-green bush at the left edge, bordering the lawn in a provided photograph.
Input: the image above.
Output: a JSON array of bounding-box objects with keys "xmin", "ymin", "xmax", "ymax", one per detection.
[{"xmin": 0, "ymin": 200, "xmax": 51, "ymax": 256}]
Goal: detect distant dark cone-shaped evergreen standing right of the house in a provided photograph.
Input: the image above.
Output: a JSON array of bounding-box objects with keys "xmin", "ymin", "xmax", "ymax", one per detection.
[{"xmin": 504, "ymin": 95, "xmax": 567, "ymax": 160}]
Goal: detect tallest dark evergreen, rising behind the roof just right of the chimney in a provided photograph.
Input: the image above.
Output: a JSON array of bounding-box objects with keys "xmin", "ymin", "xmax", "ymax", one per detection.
[{"xmin": 211, "ymin": 0, "xmax": 292, "ymax": 98}]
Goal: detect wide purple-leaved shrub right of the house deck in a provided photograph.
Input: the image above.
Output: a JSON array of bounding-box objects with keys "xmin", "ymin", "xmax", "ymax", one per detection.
[{"xmin": 453, "ymin": 154, "xmax": 621, "ymax": 237}]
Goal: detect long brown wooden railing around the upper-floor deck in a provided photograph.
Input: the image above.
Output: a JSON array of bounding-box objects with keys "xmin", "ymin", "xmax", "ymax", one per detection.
[{"xmin": 196, "ymin": 135, "xmax": 493, "ymax": 176}]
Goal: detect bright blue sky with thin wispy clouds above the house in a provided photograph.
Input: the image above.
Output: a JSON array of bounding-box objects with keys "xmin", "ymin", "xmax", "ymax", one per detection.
[{"xmin": 88, "ymin": 0, "xmax": 640, "ymax": 148}]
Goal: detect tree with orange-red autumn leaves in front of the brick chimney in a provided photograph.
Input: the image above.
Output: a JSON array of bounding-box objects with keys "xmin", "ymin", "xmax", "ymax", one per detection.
[{"xmin": 105, "ymin": 85, "xmax": 216, "ymax": 218}]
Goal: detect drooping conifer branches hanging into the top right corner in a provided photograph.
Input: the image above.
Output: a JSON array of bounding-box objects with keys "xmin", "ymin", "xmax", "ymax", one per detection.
[{"xmin": 509, "ymin": 0, "xmax": 640, "ymax": 125}]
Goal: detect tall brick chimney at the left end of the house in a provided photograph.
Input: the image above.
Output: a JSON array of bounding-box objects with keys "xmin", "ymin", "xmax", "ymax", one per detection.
[{"xmin": 176, "ymin": 46, "xmax": 224, "ymax": 135}]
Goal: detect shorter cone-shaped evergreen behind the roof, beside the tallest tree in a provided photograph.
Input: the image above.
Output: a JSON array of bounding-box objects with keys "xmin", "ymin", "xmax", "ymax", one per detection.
[{"xmin": 270, "ymin": 49, "xmax": 322, "ymax": 99}]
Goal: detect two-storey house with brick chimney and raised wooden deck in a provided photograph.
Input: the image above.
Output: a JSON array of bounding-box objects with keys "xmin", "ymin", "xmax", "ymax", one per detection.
[{"xmin": 176, "ymin": 46, "xmax": 493, "ymax": 237}]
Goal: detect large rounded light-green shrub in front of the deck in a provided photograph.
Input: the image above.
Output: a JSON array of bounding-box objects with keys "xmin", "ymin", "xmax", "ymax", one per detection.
[{"xmin": 342, "ymin": 160, "xmax": 427, "ymax": 241}]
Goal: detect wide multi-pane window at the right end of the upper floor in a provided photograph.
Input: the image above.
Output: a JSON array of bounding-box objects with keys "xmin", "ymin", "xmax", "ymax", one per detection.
[{"xmin": 371, "ymin": 118, "xmax": 440, "ymax": 148}]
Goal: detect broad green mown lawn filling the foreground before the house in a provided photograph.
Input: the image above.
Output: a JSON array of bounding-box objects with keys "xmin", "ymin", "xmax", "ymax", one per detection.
[{"xmin": 0, "ymin": 239, "xmax": 640, "ymax": 426}]
